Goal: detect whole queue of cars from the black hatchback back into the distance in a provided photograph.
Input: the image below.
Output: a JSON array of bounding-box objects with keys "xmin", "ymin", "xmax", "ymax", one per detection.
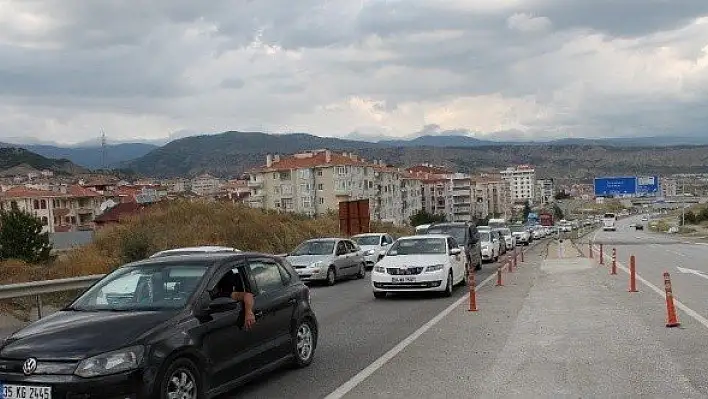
[{"xmin": 0, "ymin": 223, "xmax": 548, "ymax": 399}]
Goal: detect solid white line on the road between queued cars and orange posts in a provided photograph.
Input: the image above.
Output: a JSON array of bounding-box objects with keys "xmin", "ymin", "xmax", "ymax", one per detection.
[{"xmin": 325, "ymin": 273, "xmax": 497, "ymax": 399}]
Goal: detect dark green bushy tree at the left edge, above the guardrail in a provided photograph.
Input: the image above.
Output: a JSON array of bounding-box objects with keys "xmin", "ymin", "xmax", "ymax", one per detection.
[{"xmin": 0, "ymin": 208, "xmax": 52, "ymax": 263}]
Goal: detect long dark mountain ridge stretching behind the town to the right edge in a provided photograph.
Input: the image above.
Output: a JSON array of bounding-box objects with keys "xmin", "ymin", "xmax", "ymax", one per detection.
[{"xmin": 126, "ymin": 132, "xmax": 708, "ymax": 180}]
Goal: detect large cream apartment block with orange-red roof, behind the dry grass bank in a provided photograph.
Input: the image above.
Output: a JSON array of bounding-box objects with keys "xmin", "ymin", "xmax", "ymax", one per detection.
[{"xmin": 245, "ymin": 149, "xmax": 419, "ymax": 224}]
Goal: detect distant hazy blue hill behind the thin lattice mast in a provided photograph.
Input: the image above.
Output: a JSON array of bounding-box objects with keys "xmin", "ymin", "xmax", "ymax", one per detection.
[{"xmin": 12, "ymin": 143, "xmax": 158, "ymax": 169}]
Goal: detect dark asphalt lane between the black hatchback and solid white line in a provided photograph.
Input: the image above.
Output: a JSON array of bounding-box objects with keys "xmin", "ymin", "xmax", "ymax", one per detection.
[{"xmin": 230, "ymin": 244, "xmax": 540, "ymax": 399}]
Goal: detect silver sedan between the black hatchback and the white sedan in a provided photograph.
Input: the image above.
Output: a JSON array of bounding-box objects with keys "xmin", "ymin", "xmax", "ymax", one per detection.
[{"xmin": 285, "ymin": 238, "xmax": 366, "ymax": 285}]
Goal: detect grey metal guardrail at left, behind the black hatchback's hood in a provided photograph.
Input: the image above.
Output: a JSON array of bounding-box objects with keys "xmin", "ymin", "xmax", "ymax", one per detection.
[{"xmin": 0, "ymin": 274, "xmax": 105, "ymax": 319}]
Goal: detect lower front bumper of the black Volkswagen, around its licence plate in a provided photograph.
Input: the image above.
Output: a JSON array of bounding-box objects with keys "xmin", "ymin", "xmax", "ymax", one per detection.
[{"xmin": 0, "ymin": 371, "xmax": 152, "ymax": 399}]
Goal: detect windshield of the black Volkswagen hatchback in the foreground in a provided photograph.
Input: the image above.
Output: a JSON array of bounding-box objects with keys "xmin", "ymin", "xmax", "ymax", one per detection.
[{"xmin": 68, "ymin": 262, "xmax": 210, "ymax": 311}]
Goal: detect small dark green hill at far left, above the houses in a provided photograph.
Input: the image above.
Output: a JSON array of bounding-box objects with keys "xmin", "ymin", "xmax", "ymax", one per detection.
[{"xmin": 0, "ymin": 147, "xmax": 87, "ymax": 176}]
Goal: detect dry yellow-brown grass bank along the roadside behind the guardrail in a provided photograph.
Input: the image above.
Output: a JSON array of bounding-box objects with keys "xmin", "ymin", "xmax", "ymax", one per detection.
[{"xmin": 0, "ymin": 201, "xmax": 413, "ymax": 284}]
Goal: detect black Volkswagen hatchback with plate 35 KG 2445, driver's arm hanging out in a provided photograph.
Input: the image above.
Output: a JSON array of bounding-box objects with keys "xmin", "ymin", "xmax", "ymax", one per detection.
[{"xmin": 0, "ymin": 252, "xmax": 318, "ymax": 399}]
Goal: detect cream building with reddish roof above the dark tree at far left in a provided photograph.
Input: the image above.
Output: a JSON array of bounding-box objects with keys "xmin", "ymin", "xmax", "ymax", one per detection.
[{"xmin": 0, "ymin": 185, "xmax": 104, "ymax": 233}]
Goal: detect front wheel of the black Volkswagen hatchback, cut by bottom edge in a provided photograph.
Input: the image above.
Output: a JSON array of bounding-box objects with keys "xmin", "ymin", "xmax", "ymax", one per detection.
[{"xmin": 154, "ymin": 357, "xmax": 206, "ymax": 399}]
